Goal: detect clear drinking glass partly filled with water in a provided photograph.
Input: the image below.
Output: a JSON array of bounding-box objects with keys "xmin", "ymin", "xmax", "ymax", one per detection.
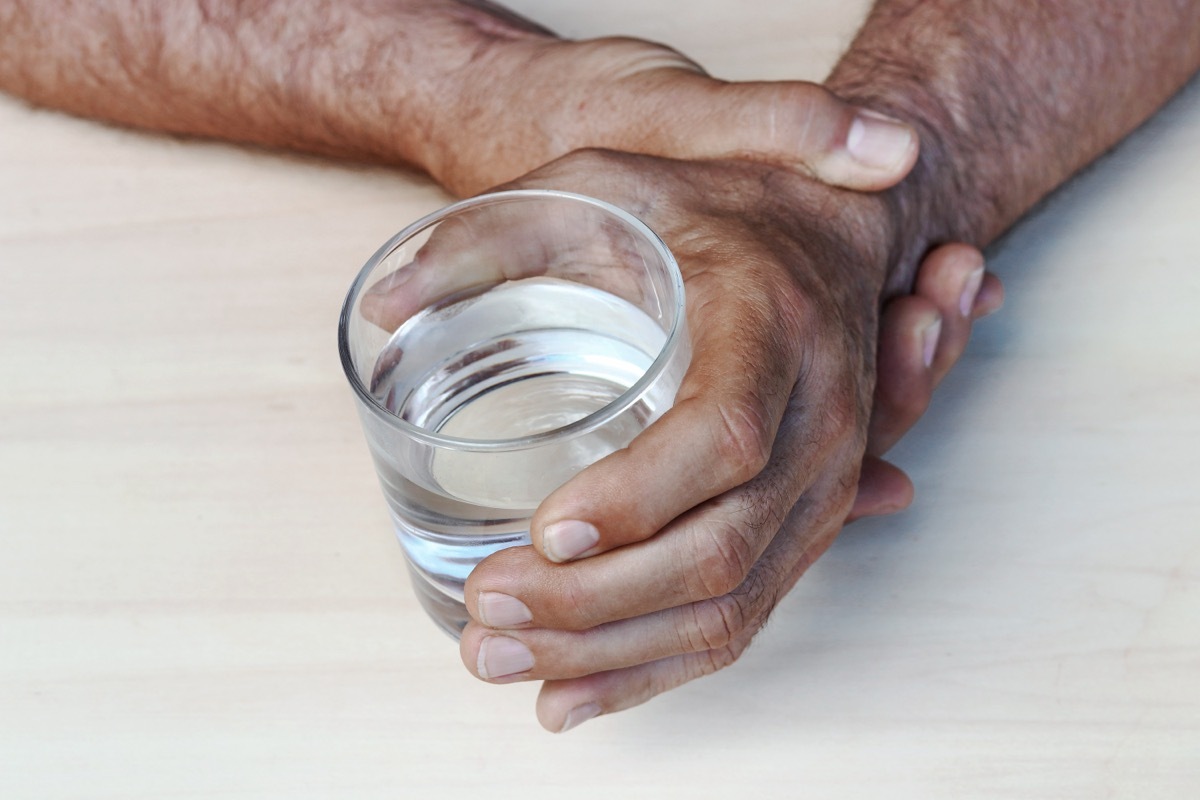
[{"xmin": 338, "ymin": 190, "xmax": 690, "ymax": 637}]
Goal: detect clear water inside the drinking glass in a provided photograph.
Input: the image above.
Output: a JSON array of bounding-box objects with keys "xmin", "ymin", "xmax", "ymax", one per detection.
[{"xmin": 371, "ymin": 278, "xmax": 676, "ymax": 636}]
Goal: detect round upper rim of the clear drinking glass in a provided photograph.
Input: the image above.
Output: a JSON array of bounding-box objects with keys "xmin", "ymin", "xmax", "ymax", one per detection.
[{"xmin": 337, "ymin": 190, "xmax": 686, "ymax": 452}]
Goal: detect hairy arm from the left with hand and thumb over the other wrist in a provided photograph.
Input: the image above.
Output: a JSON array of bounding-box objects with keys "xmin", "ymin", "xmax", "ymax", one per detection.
[{"xmin": 0, "ymin": 0, "xmax": 917, "ymax": 194}]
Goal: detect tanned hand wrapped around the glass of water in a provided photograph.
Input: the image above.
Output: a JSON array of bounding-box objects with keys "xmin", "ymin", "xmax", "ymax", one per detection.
[{"xmin": 410, "ymin": 152, "xmax": 988, "ymax": 730}]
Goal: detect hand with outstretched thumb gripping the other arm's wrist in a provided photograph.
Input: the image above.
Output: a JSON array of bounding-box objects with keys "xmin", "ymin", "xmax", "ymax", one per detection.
[{"xmin": 424, "ymin": 34, "xmax": 918, "ymax": 194}]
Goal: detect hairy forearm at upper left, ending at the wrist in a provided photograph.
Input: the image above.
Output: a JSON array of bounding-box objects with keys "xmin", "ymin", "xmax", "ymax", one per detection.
[{"xmin": 0, "ymin": 0, "xmax": 571, "ymax": 185}]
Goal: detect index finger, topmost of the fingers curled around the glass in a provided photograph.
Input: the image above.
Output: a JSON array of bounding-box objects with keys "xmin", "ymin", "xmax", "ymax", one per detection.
[{"xmin": 530, "ymin": 266, "xmax": 810, "ymax": 561}]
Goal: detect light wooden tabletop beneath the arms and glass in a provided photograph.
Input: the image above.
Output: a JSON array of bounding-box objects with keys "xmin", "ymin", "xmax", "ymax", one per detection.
[{"xmin": 0, "ymin": 0, "xmax": 1200, "ymax": 800}]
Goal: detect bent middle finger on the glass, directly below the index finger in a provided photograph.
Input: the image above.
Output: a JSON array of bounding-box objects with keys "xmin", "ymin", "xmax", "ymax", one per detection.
[{"xmin": 464, "ymin": 407, "xmax": 862, "ymax": 638}]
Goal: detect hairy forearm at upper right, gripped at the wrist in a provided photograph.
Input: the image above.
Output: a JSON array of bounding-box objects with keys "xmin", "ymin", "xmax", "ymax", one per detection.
[{"xmin": 827, "ymin": 0, "xmax": 1200, "ymax": 291}]
